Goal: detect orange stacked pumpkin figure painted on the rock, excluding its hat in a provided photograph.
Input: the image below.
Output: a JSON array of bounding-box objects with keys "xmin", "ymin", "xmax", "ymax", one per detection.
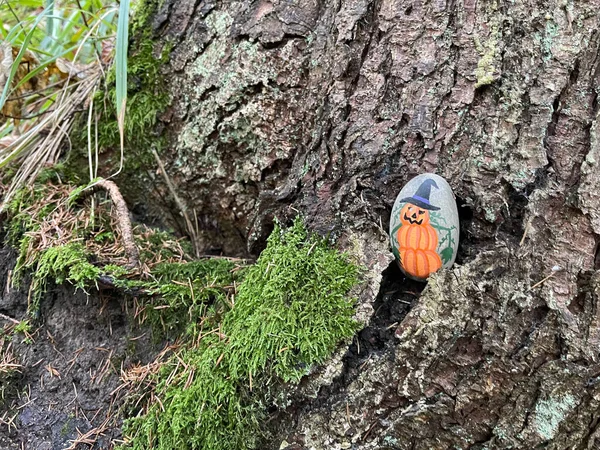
[{"xmin": 397, "ymin": 203, "xmax": 442, "ymax": 279}]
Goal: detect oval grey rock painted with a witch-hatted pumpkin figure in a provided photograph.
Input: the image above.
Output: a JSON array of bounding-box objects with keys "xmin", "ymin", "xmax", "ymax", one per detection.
[{"xmin": 390, "ymin": 173, "xmax": 459, "ymax": 281}]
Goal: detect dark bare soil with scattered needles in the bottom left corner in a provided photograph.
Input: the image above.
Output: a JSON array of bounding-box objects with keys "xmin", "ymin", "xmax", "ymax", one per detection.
[{"xmin": 0, "ymin": 249, "xmax": 158, "ymax": 450}]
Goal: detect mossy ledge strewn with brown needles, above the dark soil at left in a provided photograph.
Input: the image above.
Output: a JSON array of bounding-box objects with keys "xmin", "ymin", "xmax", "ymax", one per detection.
[{"xmin": 5, "ymin": 178, "xmax": 209, "ymax": 322}]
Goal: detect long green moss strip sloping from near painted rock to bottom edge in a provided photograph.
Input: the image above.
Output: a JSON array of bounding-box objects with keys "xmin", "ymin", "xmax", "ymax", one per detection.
[{"xmin": 123, "ymin": 220, "xmax": 358, "ymax": 450}]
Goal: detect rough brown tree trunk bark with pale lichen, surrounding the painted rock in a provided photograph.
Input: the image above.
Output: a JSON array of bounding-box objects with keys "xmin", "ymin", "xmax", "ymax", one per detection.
[{"xmin": 138, "ymin": 0, "xmax": 600, "ymax": 449}]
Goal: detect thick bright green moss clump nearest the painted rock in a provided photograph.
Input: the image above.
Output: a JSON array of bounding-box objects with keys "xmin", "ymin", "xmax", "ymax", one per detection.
[{"xmin": 223, "ymin": 220, "xmax": 358, "ymax": 382}]
